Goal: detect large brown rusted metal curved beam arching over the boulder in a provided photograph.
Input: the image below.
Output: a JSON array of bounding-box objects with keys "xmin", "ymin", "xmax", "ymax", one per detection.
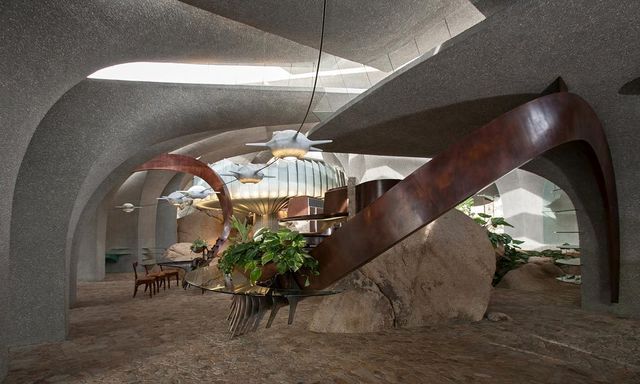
[{"xmin": 307, "ymin": 92, "xmax": 620, "ymax": 302}]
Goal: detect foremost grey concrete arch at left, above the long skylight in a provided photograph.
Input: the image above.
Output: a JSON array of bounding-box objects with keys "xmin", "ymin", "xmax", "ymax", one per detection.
[{"xmin": 0, "ymin": 0, "xmax": 316, "ymax": 364}]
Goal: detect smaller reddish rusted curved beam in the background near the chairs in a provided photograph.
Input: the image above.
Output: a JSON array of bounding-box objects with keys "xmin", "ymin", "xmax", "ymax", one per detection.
[{"xmin": 135, "ymin": 154, "xmax": 233, "ymax": 245}]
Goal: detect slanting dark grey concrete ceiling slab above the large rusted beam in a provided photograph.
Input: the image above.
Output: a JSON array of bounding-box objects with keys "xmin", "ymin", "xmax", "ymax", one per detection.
[{"xmin": 311, "ymin": 1, "xmax": 640, "ymax": 157}]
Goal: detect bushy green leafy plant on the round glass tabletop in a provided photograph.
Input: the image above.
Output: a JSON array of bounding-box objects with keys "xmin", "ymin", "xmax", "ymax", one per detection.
[{"xmin": 218, "ymin": 217, "xmax": 318, "ymax": 286}]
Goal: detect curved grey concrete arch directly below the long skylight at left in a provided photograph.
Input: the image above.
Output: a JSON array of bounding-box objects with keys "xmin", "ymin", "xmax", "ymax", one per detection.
[{"xmin": 11, "ymin": 81, "xmax": 309, "ymax": 342}]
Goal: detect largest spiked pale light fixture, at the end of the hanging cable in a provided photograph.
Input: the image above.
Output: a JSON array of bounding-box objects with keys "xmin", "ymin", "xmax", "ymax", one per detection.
[{"xmin": 247, "ymin": 129, "xmax": 333, "ymax": 160}]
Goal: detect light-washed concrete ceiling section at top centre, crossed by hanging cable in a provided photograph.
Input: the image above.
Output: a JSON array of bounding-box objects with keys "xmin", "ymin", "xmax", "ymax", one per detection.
[{"xmin": 181, "ymin": 0, "xmax": 484, "ymax": 70}]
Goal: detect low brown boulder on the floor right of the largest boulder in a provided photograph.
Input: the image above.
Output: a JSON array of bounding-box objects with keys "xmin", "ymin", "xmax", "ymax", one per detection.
[{"xmin": 498, "ymin": 262, "xmax": 564, "ymax": 292}]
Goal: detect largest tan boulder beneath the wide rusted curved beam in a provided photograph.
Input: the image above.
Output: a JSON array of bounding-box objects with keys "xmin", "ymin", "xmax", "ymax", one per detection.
[{"xmin": 310, "ymin": 210, "xmax": 495, "ymax": 332}]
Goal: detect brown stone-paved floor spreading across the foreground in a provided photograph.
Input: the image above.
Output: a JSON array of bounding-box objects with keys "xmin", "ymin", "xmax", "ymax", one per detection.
[{"xmin": 5, "ymin": 275, "xmax": 640, "ymax": 384}]
